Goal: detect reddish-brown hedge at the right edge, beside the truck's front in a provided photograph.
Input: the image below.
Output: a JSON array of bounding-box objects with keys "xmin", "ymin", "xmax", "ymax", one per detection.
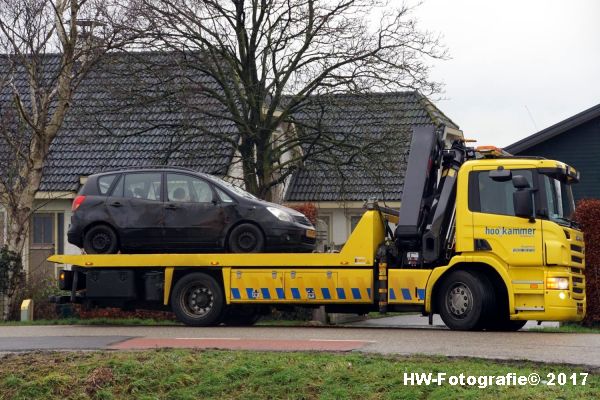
[{"xmin": 575, "ymin": 199, "xmax": 600, "ymax": 325}]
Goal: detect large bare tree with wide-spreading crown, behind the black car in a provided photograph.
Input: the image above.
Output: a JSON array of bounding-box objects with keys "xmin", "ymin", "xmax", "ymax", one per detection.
[{"xmin": 136, "ymin": 0, "xmax": 445, "ymax": 199}]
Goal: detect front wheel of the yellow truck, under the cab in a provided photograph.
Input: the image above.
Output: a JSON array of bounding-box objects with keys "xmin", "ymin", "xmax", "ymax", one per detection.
[{"xmin": 438, "ymin": 271, "xmax": 494, "ymax": 331}]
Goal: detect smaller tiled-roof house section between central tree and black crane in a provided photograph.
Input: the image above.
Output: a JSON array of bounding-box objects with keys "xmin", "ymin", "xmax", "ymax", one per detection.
[{"xmin": 284, "ymin": 91, "xmax": 462, "ymax": 248}]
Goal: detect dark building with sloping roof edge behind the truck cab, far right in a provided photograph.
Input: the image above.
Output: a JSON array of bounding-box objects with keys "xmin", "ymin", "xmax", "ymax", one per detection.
[{"xmin": 505, "ymin": 104, "xmax": 600, "ymax": 200}]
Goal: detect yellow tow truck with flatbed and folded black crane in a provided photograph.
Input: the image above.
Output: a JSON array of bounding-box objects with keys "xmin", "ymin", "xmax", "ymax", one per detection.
[{"xmin": 49, "ymin": 126, "xmax": 586, "ymax": 330}]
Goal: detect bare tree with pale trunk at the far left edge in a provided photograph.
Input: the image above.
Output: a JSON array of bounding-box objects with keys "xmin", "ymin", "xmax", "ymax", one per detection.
[{"xmin": 0, "ymin": 0, "xmax": 137, "ymax": 317}]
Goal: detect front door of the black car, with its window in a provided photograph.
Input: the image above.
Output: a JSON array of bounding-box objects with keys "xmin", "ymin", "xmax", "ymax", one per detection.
[{"xmin": 165, "ymin": 173, "xmax": 225, "ymax": 249}]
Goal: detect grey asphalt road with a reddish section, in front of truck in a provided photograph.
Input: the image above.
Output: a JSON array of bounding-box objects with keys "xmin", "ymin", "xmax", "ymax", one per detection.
[{"xmin": 0, "ymin": 326, "xmax": 600, "ymax": 369}]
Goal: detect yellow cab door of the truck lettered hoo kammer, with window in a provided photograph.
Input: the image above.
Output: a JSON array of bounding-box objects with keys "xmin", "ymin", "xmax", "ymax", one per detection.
[{"xmin": 469, "ymin": 166, "xmax": 543, "ymax": 266}]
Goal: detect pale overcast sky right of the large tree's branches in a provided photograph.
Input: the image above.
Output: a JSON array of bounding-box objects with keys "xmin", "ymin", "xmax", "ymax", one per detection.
[{"xmin": 415, "ymin": 0, "xmax": 600, "ymax": 146}]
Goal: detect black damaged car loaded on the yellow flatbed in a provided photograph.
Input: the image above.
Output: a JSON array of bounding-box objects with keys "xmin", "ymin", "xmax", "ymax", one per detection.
[{"xmin": 67, "ymin": 167, "xmax": 316, "ymax": 254}]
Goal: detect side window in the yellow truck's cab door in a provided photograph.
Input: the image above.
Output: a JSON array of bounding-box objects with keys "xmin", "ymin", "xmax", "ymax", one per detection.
[{"xmin": 469, "ymin": 169, "xmax": 533, "ymax": 215}]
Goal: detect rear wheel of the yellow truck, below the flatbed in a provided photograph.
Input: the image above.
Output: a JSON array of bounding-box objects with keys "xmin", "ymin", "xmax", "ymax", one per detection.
[{"xmin": 171, "ymin": 272, "xmax": 223, "ymax": 326}]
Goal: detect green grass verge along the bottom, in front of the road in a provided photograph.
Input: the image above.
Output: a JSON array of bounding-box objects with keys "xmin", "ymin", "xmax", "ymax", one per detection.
[{"xmin": 0, "ymin": 349, "xmax": 600, "ymax": 400}]
